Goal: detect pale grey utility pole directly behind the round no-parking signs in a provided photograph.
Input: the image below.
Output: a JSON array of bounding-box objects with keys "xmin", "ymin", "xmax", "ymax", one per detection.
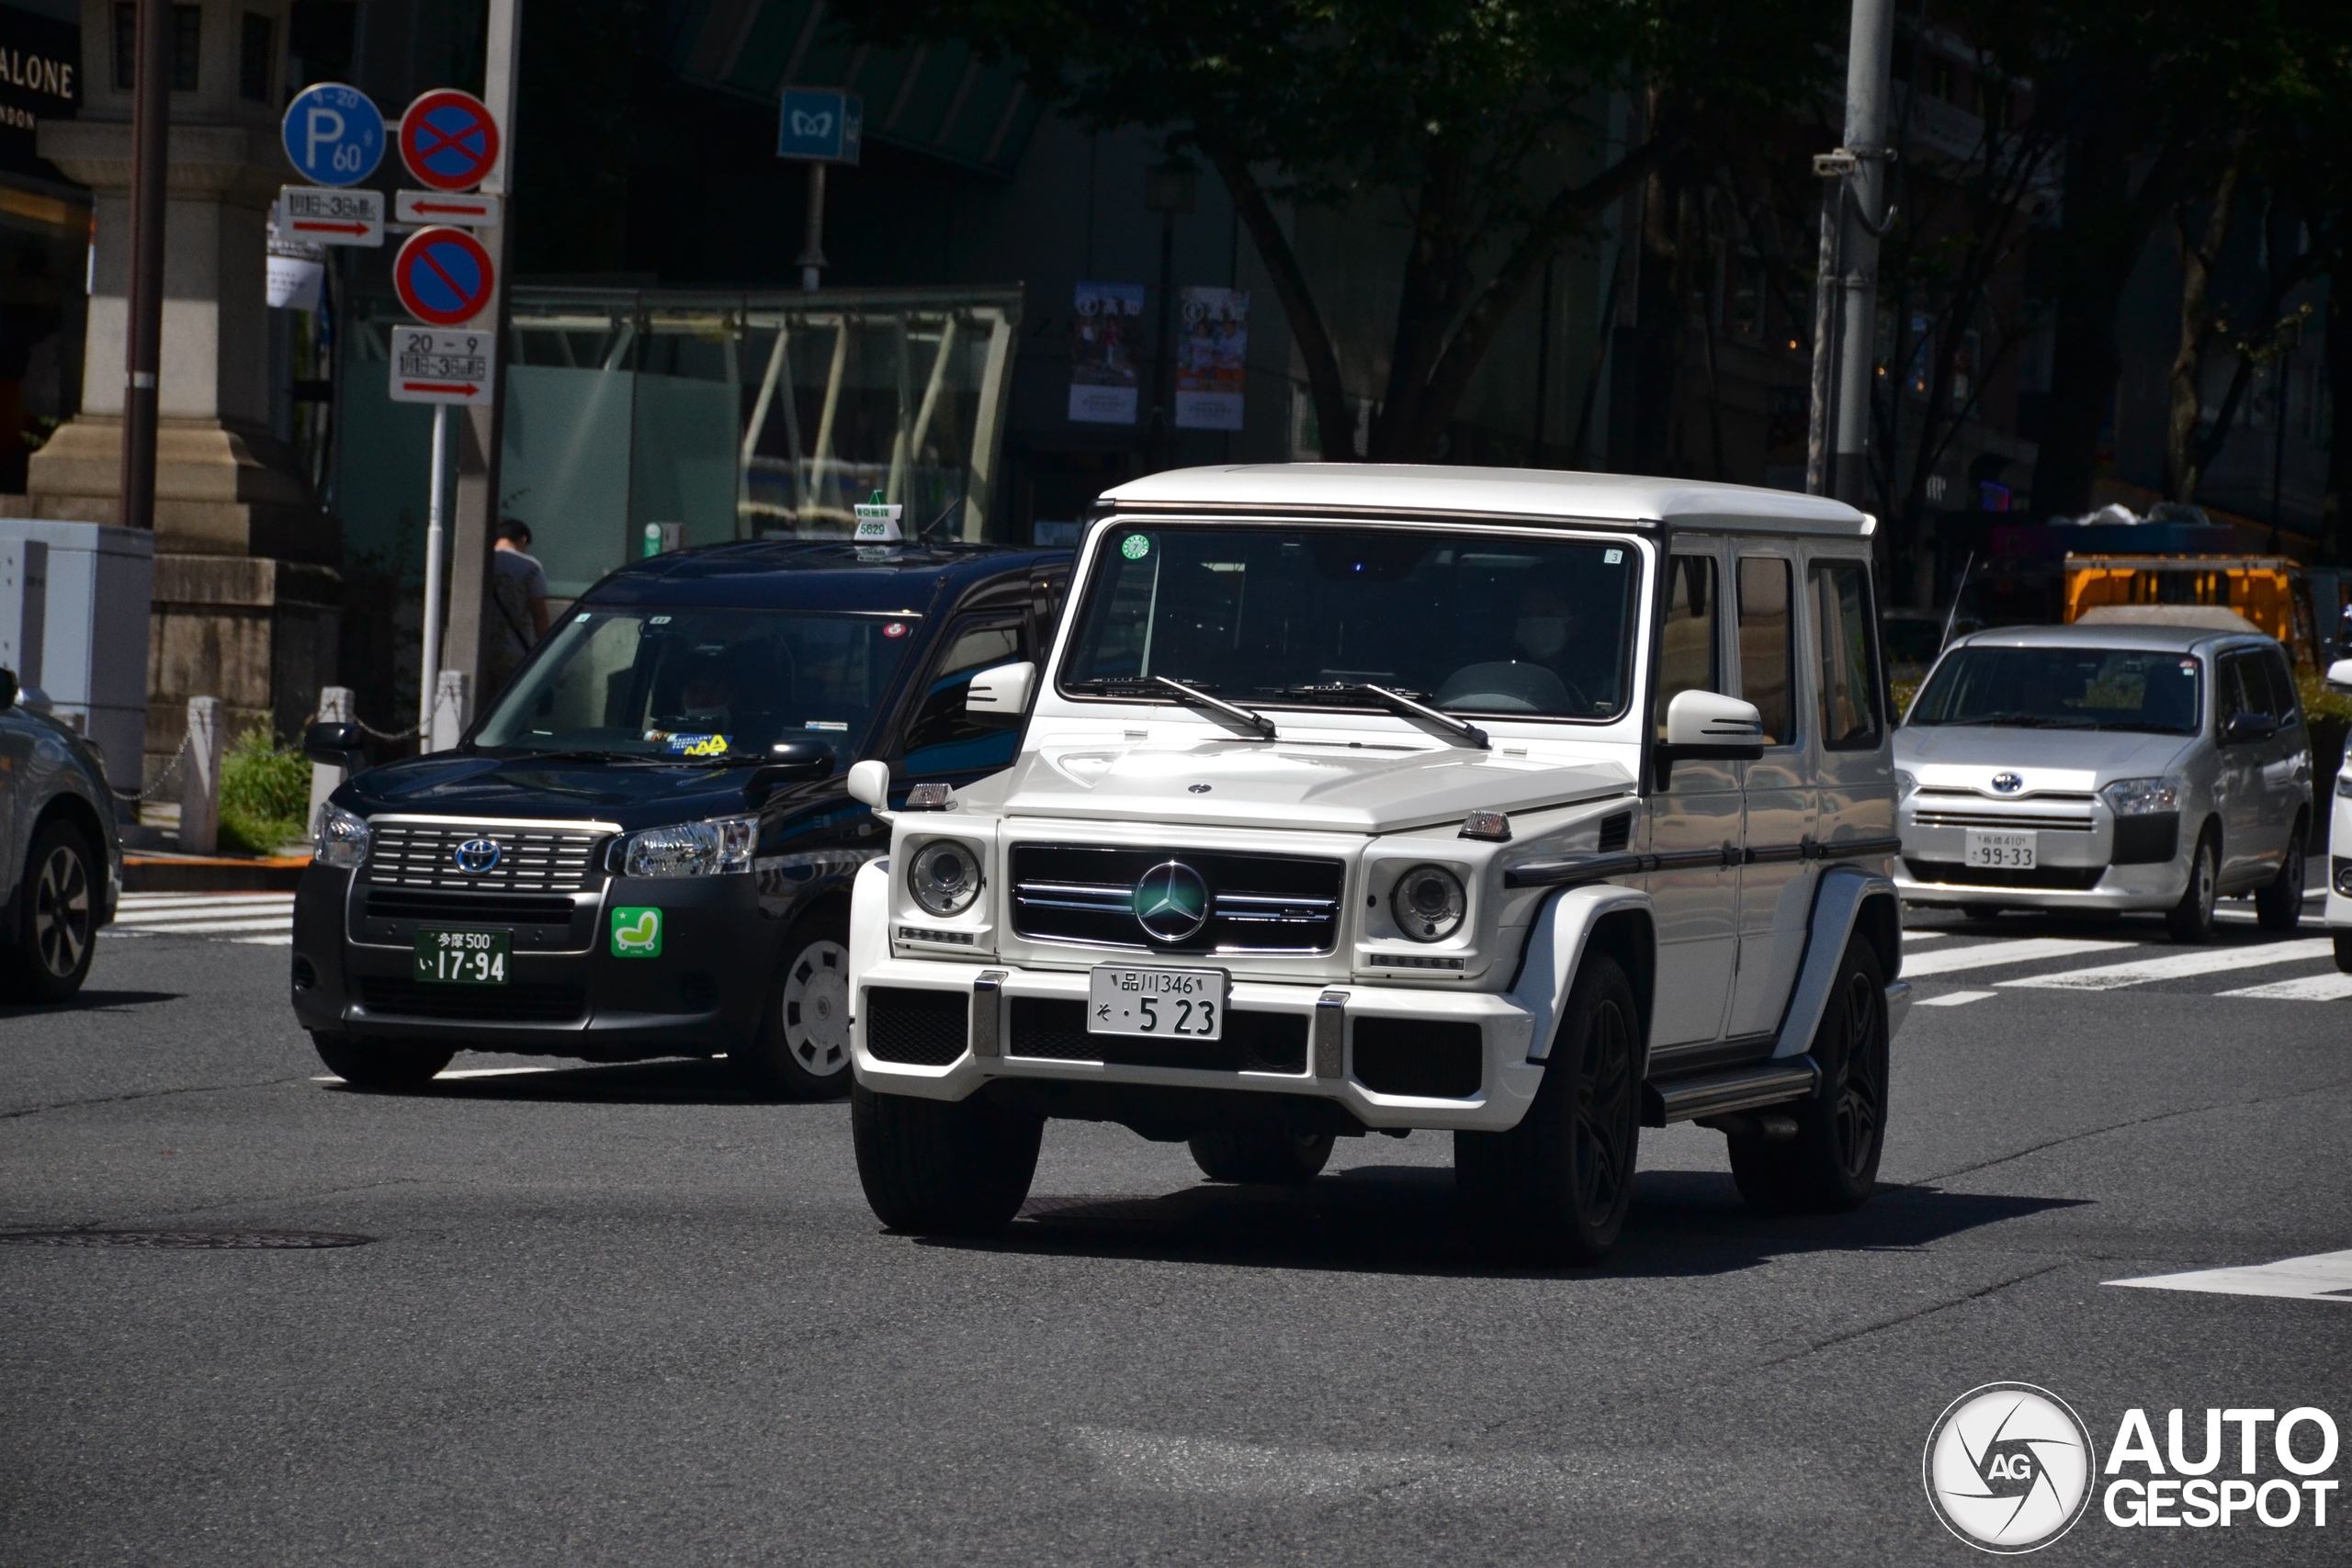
[{"xmin": 439, "ymin": 0, "xmax": 522, "ymax": 705}]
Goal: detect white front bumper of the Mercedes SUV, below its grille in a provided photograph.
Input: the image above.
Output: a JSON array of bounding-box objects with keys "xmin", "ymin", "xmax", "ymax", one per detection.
[{"xmin": 852, "ymin": 959, "xmax": 1543, "ymax": 1134}]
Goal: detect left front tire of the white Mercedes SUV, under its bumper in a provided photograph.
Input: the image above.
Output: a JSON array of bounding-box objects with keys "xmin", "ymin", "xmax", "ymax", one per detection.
[{"xmin": 849, "ymin": 1084, "xmax": 1045, "ymax": 1236}]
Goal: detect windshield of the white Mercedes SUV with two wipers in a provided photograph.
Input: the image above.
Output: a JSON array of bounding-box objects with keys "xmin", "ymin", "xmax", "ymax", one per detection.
[{"xmin": 1061, "ymin": 525, "xmax": 1639, "ymax": 719}]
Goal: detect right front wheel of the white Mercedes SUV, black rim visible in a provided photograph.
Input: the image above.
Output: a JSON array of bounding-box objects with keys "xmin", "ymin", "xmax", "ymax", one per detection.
[{"xmin": 1453, "ymin": 954, "xmax": 1642, "ymax": 1262}]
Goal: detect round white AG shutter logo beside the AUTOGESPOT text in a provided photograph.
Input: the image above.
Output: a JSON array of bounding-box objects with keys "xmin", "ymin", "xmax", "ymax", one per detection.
[{"xmin": 1922, "ymin": 1382, "xmax": 2098, "ymax": 1556}]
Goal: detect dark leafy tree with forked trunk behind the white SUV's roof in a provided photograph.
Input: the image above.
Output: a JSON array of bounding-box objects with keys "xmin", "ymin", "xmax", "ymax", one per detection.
[{"xmin": 854, "ymin": 0, "xmax": 1844, "ymax": 461}]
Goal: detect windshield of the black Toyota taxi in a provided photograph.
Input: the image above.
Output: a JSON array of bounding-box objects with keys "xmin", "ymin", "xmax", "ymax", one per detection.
[{"xmin": 475, "ymin": 606, "xmax": 917, "ymax": 766}]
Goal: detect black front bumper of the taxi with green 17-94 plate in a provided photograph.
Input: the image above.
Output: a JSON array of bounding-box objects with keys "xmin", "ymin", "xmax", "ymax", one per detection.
[{"xmin": 291, "ymin": 863, "xmax": 788, "ymax": 1060}]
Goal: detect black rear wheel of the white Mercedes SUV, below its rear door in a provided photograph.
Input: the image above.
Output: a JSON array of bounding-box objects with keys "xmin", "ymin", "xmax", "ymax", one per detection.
[{"xmin": 1731, "ymin": 936, "xmax": 1889, "ymax": 1213}]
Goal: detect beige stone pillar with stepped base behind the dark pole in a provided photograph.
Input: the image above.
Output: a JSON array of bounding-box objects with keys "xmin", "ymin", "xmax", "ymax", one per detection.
[{"xmin": 26, "ymin": 0, "xmax": 344, "ymax": 778}]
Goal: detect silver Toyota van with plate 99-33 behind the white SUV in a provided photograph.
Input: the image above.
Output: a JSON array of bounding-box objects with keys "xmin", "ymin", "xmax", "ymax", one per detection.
[{"xmin": 1895, "ymin": 611, "xmax": 2312, "ymax": 942}]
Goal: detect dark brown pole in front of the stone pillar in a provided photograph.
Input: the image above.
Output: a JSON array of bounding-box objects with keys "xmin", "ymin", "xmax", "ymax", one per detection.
[{"xmin": 122, "ymin": 0, "xmax": 172, "ymax": 531}]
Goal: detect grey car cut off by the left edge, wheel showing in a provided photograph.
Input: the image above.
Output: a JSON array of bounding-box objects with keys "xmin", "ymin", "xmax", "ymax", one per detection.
[{"xmin": 0, "ymin": 670, "xmax": 122, "ymax": 1001}]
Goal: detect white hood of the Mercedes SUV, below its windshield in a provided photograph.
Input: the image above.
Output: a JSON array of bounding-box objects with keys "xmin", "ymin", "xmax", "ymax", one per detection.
[{"xmin": 1000, "ymin": 740, "xmax": 1634, "ymax": 832}]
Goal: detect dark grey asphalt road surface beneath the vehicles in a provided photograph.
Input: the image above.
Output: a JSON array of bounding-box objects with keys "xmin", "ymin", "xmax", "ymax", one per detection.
[{"xmin": 0, "ymin": 917, "xmax": 2352, "ymax": 1568}]
